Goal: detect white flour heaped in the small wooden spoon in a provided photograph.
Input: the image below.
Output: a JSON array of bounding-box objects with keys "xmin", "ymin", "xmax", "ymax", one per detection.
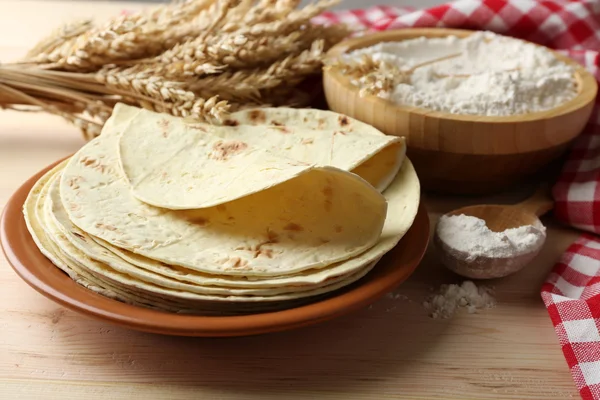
[{"xmin": 436, "ymin": 214, "xmax": 546, "ymax": 261}]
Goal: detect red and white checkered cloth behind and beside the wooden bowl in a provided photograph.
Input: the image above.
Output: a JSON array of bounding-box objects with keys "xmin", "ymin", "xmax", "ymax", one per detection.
[{"xmin": 315, "ymin": 0, "xmax": 600, "ymax": 400}]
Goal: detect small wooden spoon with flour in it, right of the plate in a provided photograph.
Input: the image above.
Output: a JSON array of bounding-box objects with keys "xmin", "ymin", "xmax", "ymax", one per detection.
[{"xmin": 434, "ymin": 187, "xmax": 554, "ymax": 279}]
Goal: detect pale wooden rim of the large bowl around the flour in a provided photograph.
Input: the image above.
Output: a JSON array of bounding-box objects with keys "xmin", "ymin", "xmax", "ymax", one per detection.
[{"xmin": 323, "ymin": 28, "xmax": 598, "ymax": 124}]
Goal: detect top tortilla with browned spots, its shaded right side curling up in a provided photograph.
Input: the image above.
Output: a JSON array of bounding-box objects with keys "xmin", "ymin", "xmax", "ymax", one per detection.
[{"xmin": 60, "ymin": 107, "xmax": 387, "ymax": 276}]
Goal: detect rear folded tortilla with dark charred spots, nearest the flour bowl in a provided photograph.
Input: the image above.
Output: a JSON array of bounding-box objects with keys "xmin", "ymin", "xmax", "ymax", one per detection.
[{"xmin": 214, "ymin": 107, "xmax": 406, "ymax": 192}]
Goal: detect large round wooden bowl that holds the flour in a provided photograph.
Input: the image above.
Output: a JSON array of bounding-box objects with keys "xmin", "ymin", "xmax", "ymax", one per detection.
[{"xmin": 323, "ymin": 28, "xmax": 598, "ymax": 194}]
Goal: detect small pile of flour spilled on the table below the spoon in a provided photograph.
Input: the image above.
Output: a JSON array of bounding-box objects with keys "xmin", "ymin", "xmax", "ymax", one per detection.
[{"xmin": 423, "ymin": 281, "xmax": 496, "ymax": 318}]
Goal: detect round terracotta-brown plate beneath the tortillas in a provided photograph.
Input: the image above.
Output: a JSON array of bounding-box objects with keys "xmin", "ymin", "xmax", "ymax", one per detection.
[{"xmin": 0, "ymin": 161, "xmax": 429, "ymax": 336}]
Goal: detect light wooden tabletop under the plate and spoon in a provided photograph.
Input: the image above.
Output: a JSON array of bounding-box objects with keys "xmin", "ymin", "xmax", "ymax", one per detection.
[{"xmin": 0, "ymin": 0, "xmax": 578, "ymax": 400}]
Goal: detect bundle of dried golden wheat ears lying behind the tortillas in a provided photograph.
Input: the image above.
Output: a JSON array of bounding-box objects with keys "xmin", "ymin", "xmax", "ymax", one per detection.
[{"xmin": 0, "ymin": 0, "xmax": 352, "ymax": 138}]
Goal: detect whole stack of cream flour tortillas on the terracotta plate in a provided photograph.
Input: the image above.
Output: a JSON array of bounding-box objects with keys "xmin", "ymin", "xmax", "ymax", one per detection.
[{"xmin": 24, "ymin": 104, "xmax": 420, "ymax": 314}]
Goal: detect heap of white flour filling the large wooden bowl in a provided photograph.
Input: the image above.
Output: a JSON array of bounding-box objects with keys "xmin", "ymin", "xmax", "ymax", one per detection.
[{"xmin": 344, "ymin": 32, "xmax": 577, "ymax": 116}]
